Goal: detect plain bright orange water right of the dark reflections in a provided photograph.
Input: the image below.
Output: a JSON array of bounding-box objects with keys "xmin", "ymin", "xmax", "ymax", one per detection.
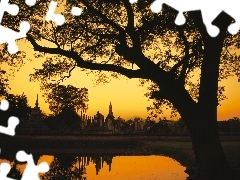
[{"xmin": 82, "ymin": 156, "xmax": 188, "ymax": 180}]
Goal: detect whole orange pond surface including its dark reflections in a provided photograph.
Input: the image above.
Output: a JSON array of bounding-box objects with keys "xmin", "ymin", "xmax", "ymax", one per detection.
[{"xmin": 0, "ymin": 154, "xmax": 188, "ymax": 180}]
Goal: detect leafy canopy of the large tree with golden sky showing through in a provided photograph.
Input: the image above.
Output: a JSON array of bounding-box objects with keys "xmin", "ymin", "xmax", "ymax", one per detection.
[{"xmin": 1, "ymin": 0, "xmax": 240, "ymax": 116}]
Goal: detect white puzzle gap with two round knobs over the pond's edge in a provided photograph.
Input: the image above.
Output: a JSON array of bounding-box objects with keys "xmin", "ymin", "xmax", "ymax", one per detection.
[{"xmin": 16, "ymin": 151, "xmax": 49, "ymax": 180}]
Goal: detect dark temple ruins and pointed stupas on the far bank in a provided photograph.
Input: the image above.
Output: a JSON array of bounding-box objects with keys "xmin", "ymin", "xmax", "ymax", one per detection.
[{"xmin": 18, "ymin": 94, "xmax": 144, "ymax": 134}]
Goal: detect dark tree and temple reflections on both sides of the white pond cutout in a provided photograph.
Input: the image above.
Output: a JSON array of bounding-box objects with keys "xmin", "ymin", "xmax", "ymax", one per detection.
[{"xmin": 2, "ymin": 154, "xmax": 113, "ymax": 180}]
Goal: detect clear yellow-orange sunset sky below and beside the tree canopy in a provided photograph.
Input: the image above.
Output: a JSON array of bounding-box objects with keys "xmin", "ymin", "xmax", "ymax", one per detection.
[{"xmin": 1, "ymin": 40, "xmax": 240, "ymax": 120}]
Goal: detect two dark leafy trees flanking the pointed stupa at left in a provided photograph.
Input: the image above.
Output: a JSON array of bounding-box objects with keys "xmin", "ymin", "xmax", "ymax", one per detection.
[{"xmin": 0, "ymin": 85, "xmax": 88, "ymax": 133}]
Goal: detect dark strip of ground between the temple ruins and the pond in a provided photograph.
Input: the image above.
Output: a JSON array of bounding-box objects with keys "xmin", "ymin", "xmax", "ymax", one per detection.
[{"xmin": 0, "ymin": 135, "xmax": 240, "ymax": 179}]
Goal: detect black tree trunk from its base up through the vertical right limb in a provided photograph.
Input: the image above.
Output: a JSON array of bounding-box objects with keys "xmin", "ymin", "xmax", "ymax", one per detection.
[{"xmin": 184, "ymin": 13, "xmax": 233, "ymax": 180}]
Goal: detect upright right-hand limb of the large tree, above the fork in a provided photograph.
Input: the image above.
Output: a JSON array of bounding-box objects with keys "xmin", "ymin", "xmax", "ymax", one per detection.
[{"xmin": 191, "ymin": 12, "xmax": 232, "ymax": 107}]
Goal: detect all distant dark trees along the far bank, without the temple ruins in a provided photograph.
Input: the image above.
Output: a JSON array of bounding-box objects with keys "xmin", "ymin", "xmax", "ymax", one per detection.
[{"xmin": 0, "ymin": 85, "xmax": 240, "ymax": 135}]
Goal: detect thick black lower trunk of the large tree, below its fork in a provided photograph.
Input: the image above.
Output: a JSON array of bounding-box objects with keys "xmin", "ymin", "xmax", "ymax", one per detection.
[{"xmin": 188, "ymin": 109, "xmax": 231, "ymax": 180}]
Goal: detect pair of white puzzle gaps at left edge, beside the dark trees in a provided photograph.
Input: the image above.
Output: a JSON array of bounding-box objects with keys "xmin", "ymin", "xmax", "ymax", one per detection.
[{"xmin": 0, "ymin": 100, "xmax": 19, "ymax": 136}]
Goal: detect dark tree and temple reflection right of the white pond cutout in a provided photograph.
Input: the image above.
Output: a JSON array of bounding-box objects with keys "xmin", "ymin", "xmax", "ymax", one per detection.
[{"xmin": 41, "ymin": 155, "xmax": 113, "ymax": 180}]
